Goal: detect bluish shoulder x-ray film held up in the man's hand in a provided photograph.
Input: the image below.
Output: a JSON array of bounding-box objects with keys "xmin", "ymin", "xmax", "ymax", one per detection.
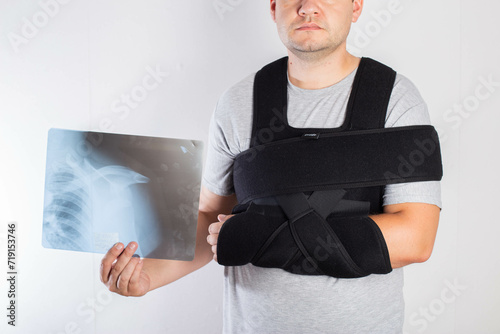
[{"xmin": 42, "ymin": 129, "xmax": 203, "ymax": 261}]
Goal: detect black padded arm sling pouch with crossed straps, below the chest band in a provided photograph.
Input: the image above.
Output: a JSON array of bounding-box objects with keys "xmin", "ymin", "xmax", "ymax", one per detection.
[{"xmin": 217, "ymin": 194, "xmax": 392, "ymax": 278}]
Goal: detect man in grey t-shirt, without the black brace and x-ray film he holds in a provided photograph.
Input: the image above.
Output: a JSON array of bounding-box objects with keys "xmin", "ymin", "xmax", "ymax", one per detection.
[{"xmin": 101, "ymin": 0, "xmax": 441, "ymax": 333}]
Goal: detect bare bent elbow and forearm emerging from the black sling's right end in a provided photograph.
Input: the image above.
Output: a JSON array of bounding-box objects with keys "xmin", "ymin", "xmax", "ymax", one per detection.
[{"xmin": 370, "ymin": 203, "xmax": 440, "ymax": 268}]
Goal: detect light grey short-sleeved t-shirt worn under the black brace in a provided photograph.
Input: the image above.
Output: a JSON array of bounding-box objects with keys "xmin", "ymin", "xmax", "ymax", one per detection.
[{"xmin": 203, "ymin": 64, "xmax": 441, "ymax": 334}]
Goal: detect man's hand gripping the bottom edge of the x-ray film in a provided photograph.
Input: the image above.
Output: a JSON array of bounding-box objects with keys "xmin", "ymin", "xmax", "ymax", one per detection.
[{"xmin": 100, "ymin": 241, "xmax": 151, "ymax": 297}]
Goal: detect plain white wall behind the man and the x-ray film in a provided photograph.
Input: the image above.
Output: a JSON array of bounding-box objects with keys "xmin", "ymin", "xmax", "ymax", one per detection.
[{"xmin": 0, "ymin": 0, "xmax": 500, "ymax": 333}]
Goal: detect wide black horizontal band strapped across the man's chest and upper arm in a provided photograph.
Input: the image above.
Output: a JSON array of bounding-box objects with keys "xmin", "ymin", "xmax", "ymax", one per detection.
[{"xmin": 233, "ymin": 125, "xmax": 443, "ymax": 203}]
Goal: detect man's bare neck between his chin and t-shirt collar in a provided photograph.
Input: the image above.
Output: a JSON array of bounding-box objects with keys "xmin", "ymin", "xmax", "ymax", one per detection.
[{"xmin": 288, "ymin": 51, "xmax": 360, "ymax": 89}]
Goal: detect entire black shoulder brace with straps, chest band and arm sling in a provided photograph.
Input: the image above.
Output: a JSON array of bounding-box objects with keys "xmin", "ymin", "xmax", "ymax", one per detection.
[{"xmin": 217, "ymin": 58, "xmax": 442, "ymax": 278}]
